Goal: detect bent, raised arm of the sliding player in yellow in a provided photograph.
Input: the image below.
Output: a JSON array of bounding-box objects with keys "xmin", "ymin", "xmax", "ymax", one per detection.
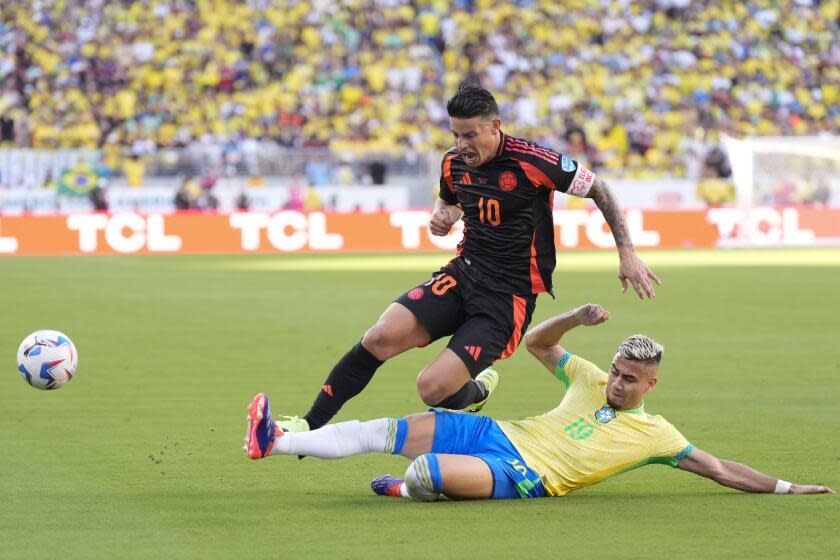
[{"xmin": 525, "ymin": 303, "xmax": 610, "ymax": 374}]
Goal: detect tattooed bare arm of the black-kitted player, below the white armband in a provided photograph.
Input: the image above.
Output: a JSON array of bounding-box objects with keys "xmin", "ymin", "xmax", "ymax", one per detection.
[{"xmin": 587, "ymin": 176, "xmax": 662, "ymax": 299}]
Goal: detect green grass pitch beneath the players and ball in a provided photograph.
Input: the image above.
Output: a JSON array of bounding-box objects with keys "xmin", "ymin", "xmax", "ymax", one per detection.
[{"xmin": 0, "ymin": 250, "xmax": 840, "ymax": 559}]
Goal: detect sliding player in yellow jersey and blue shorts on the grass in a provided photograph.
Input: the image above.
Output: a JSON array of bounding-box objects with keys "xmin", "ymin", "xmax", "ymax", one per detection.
[{"xmin": 245, "ymin": 304, "xmax": 834, "ymax": 501}]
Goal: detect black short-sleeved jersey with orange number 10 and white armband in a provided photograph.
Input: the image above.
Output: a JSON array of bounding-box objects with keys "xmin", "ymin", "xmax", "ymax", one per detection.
[{"xmin": 440, "ymin": 132, "xmax": 595, "ymax": 295}]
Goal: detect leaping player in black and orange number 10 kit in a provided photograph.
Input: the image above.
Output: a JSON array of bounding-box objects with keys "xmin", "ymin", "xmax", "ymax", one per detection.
[{"xmin": 277, "ymin": 84, "xmax": 661, "ymax": 431}]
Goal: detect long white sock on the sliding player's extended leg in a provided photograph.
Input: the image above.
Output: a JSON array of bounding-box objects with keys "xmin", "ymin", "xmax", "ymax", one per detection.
[{"xmin": 271, "ymin": 418, "xmax": 397, "ymax": 459}]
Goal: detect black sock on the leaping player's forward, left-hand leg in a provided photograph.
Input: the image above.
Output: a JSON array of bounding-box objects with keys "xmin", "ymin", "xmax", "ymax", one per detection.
[{"xmin": 303, "ymin": 342, "xmax": 384, "ymax": 430}]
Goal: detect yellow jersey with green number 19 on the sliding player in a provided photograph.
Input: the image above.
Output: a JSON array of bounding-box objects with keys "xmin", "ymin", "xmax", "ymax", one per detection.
[{"xmin": 498, "ymin": 352, "xmax": 694, "ymax": 496}]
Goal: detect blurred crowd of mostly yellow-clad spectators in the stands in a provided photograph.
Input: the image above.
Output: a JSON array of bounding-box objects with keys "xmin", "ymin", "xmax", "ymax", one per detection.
[{"xmin": 0, "ymin": 0, "xmax": 840, "ymax": 177}]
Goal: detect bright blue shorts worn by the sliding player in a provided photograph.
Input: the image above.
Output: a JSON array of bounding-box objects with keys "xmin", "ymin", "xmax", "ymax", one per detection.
[{"xmin": 431, "ymin": 408, "xmax": 545, "ymax": 500}]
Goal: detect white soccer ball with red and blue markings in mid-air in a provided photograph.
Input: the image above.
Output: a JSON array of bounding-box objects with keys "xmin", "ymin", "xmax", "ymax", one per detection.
[{"xmin": 18, "ymin": 331, "xmax": 79, "ymax": 390}]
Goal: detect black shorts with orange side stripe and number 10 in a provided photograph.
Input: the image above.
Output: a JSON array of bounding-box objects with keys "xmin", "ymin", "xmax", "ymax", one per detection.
[{"xmin": 396, "ymin": 260, "xmax": 537, "ymax": 377}]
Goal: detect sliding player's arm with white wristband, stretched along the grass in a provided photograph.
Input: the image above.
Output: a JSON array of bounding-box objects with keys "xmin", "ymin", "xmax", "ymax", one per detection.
[{"xmin": 677, "ymin": 447, "xmax": 835, "ymax": 494}]
